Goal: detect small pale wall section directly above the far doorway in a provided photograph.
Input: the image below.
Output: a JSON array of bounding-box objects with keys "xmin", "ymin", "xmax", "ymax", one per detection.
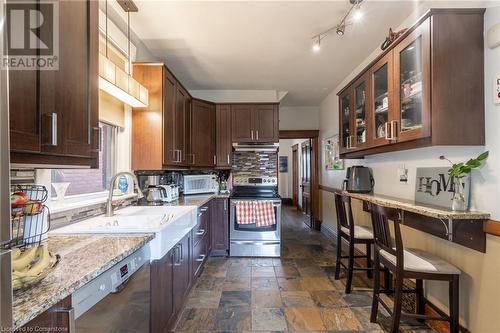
[{"xmin": 280, "ymin": 106, "xmax": 319, "ymax": 130}]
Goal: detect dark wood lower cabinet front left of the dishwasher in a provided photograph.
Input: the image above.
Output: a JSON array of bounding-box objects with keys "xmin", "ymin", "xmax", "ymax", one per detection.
[{"xmin": 17, "ymin": 296, "xmax": 74, "ymax": 333}]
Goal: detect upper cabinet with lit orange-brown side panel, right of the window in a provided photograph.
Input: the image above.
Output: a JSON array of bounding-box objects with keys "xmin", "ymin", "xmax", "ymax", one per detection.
[{"xmin": 132, "ymin": 63, "xmax": 191, "ymax": 170}]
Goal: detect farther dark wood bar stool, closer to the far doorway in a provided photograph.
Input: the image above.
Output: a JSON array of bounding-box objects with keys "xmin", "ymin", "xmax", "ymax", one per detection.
[{"xmin": 335, "ymin": 193, "xmax": 373, "ymax": 294}]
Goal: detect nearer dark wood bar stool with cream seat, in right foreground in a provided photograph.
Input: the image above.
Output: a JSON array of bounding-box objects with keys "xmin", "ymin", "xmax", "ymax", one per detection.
[{"xmin": 370, "ymin": 204, "xmax": 460, "ymax": 333}]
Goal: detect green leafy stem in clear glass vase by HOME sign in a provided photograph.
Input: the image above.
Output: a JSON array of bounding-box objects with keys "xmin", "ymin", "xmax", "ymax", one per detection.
[{"xmin": 439, "ymin": 151, "xmax": 489, "ymax": 211}]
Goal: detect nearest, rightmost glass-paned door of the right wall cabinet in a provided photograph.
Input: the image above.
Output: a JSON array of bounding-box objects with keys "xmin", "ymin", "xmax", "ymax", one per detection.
[{"xmin": 391, "ymin": 19, "xmax": 431, "ymax": 141}]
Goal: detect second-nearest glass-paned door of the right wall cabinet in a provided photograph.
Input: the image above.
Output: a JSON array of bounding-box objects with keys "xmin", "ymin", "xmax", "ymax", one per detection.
[{"xmin": 369, "ymin": 52, "xmax": 394, "ymax": 146}]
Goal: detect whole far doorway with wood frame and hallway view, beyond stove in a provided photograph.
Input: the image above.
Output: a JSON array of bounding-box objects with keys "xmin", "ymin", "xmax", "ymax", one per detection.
[{"xmin": 280, "ymin": 130, "xmax": 321, "ymax": 230}]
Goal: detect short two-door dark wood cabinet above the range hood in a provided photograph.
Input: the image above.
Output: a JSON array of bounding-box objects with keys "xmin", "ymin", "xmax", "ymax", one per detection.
[{"xmin": 231, "ymin": 104, "xmax": 279, "ymax": 143}]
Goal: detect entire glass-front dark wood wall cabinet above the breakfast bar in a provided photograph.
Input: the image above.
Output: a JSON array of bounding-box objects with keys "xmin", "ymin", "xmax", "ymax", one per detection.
[{"xmin": 338, "ymin": 8, "xmax": 484, "ymax": 158}]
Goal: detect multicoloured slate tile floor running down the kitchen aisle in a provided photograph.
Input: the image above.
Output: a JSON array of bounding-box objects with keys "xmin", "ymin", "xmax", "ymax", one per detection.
[{"xmin": 175, "ymin": 206, "xmax": 433, "ymax": 333}]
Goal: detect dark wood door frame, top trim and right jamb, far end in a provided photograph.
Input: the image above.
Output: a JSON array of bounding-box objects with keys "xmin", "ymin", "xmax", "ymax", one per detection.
[{"xmin": 279, "ymin": 130, "xmax": 321, "ymax": 230}]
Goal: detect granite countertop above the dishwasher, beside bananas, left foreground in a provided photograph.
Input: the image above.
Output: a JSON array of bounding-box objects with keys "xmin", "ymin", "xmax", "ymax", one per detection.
[{"xmin": 13, "ymin": 234, "xmax": 154, "ymax": 329}]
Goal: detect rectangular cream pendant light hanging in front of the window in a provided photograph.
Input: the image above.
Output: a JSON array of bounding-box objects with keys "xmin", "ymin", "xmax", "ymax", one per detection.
[{"xmin": 99, "ymin": 0, "xmax": 149, "ymax": 108}]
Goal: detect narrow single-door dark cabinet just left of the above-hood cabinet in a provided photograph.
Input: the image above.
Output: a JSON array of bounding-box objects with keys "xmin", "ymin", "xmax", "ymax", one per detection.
[{"xmin": 215, "ymin": 104, "xmax": 233, "ymax": 168}]
